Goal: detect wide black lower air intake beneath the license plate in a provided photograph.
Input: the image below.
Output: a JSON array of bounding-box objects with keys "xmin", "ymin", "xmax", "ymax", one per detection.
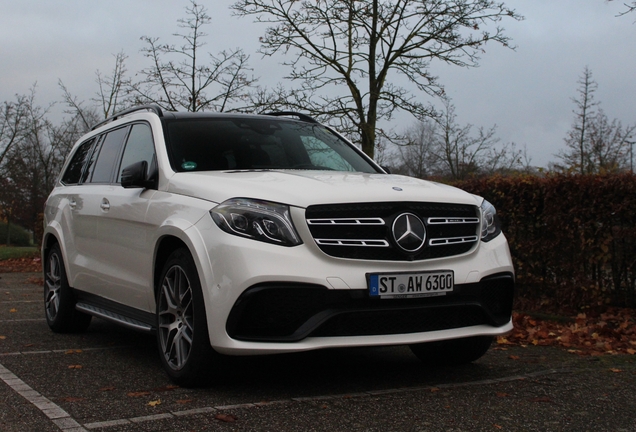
[{"xmin": 226, "ymin": 273, "xmax": 514, "ymax": 342}]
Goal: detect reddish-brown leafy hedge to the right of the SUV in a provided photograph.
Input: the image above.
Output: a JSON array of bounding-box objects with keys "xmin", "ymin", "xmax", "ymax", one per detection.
[{"xmin": 455, "ymin": 173, "xmax": 636, "ymax": 311}]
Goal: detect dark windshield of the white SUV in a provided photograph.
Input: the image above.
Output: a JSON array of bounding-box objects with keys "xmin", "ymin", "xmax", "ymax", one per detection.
[{"xmin": 165, "ymin": 118, "xmax": 378, "ymax": 173}]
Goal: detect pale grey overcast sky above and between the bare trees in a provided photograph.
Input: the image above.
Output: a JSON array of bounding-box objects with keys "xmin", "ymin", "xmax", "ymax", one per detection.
[{"xmin": 0, "ymin": 0, "xmax": 636, "ymax": 166}]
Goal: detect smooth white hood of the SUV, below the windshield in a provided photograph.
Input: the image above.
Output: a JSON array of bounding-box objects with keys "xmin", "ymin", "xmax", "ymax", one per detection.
[{"xmin": 168, "ymin": 170, "xmax": 479, "ymax": 208}]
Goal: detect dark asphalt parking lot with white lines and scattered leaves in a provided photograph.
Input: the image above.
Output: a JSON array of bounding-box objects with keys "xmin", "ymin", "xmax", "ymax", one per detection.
[{"xmin": 0, "ymin": 273, "xmax": 636, "ymax": 432}]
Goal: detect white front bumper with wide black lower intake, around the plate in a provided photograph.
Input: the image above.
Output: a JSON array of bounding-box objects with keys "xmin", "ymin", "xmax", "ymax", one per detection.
[{"xmin": 191, "ymin": 208, "xmax": 514, "ymax": 355}]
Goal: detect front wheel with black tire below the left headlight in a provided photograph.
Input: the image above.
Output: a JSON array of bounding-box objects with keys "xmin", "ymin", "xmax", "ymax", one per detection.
[{"xmin": 157, "ymin": 249, "xmax": 218, "ymax": 387}]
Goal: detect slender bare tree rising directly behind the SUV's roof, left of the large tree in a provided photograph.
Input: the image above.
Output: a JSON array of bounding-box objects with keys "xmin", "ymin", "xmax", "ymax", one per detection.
[{"xmin": 130, "ymin": 1, "xmax": 256, "ymax": 111}]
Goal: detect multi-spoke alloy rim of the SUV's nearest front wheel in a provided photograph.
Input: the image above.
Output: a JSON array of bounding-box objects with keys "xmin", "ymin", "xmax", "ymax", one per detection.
[{"xmin": 158, "ymin": 265, "xmax": 194, "ymax": 370}]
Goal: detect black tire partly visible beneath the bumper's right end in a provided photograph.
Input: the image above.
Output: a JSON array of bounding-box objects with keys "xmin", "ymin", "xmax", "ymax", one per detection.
[{"xmin": 409, "ymin": 336, "xmax": 493, "ymax": 366}]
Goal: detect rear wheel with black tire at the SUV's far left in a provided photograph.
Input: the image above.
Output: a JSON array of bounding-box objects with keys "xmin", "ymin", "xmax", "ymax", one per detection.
[{"xmin": 44, "ymin": 243, "xmax": 92, "ymax": 333}]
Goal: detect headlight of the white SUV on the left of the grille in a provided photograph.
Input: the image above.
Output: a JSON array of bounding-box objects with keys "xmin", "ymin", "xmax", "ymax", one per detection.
[{"xmin": 210, "ymin": 198, "xmax": 302, "ymax": 246}]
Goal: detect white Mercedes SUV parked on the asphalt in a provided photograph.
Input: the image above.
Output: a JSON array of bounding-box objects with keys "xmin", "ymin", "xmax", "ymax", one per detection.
[{"xmin": 42, "ymin": 106, "xmax": 514, "ymax": 385}]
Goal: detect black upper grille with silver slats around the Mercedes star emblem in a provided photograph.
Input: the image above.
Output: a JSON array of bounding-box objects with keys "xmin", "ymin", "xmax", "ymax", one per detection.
[{"xmin": 305, "ymin": 202, "xmax": 480, "ymax": 261}]
